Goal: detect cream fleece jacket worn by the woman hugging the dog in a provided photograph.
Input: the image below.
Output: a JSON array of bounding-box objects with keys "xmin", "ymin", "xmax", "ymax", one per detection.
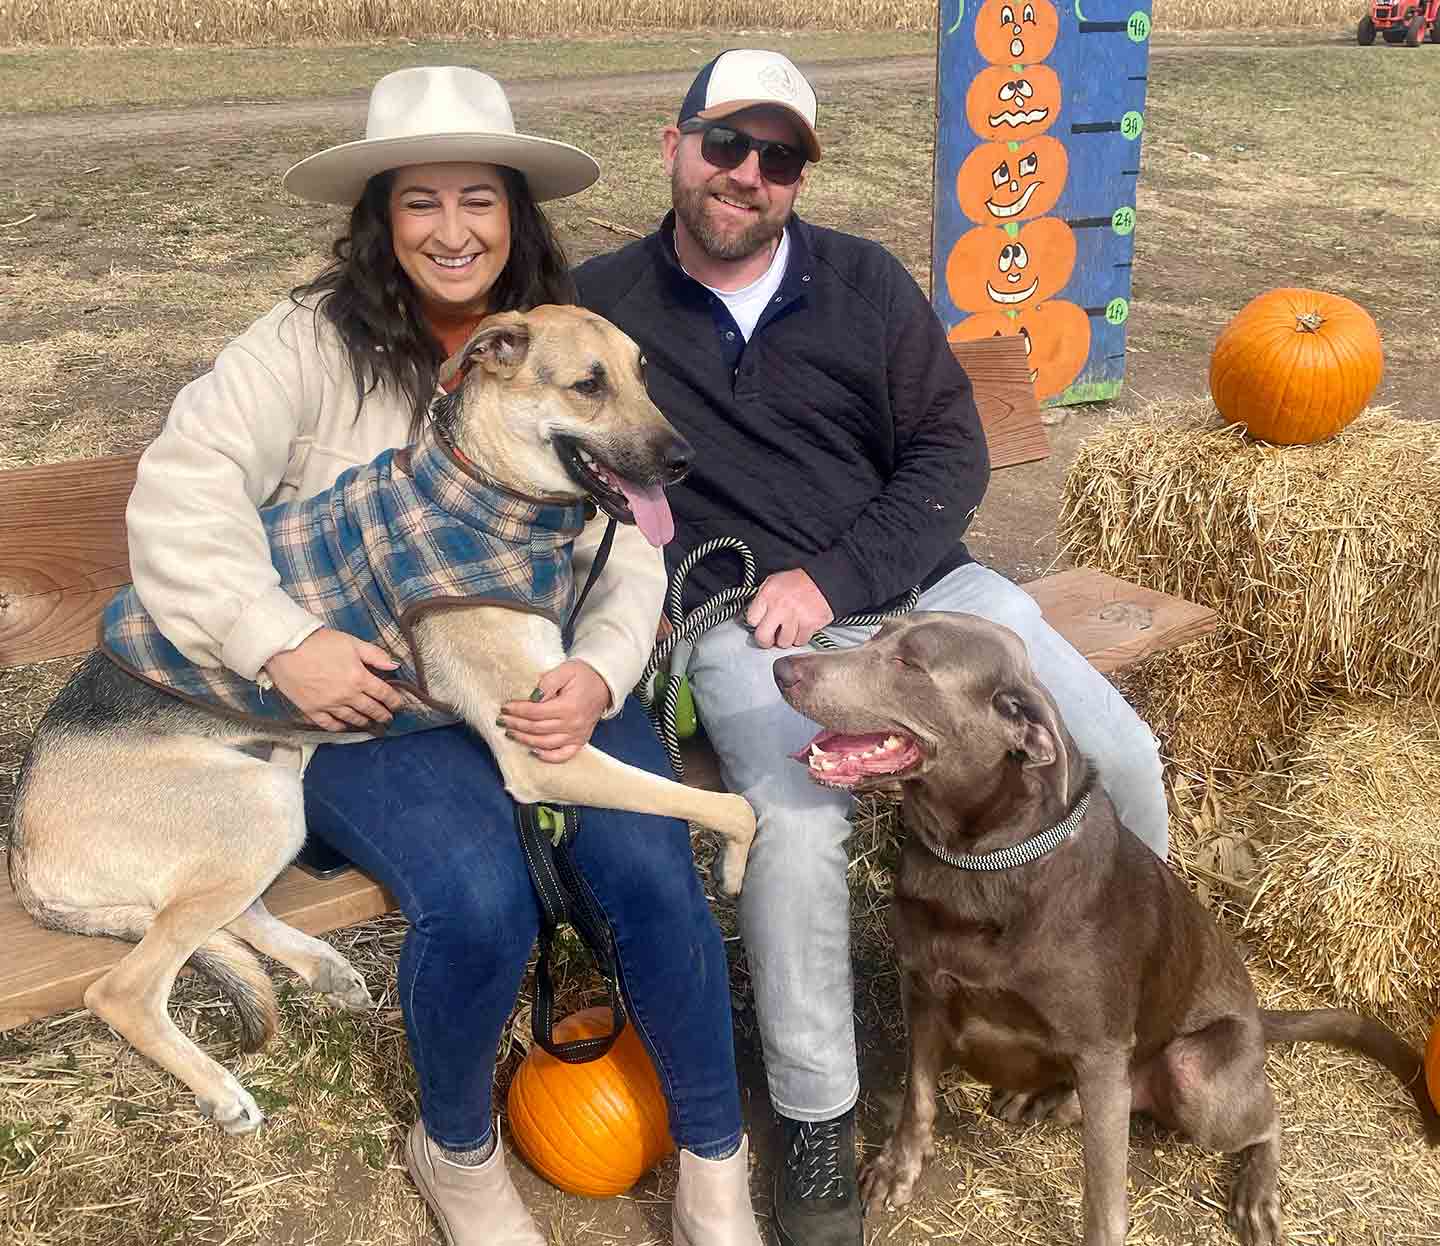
[{"xmin": 125, "ymin": 300, "xmax": 665, "ymax": 717}]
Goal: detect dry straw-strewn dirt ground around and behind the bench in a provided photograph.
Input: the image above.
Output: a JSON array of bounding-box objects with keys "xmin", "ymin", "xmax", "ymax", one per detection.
[{"xmin": 0, "ymin": 33, "xmax": 1440, "ymax": 1246}]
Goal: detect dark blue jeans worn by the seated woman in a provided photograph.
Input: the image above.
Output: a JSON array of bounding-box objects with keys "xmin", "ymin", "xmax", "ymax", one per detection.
[{"xmin": 305, "ymin": 700, "xmax": 742, "ymax": 1158}]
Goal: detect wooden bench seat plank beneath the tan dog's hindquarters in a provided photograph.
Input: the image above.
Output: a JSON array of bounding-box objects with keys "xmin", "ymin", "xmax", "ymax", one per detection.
[{"xmin": 0, "ymin": 869, "xmax": 395, "ymax": 1031}]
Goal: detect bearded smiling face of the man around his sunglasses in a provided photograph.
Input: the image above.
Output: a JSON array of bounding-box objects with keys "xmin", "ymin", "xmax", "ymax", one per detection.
[{"xmin": 664, "ymin": 109, "xmax": 805, "ymax": 268}]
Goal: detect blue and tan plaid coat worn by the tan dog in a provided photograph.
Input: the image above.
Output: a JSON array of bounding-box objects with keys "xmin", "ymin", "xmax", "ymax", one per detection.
[{"xmin": 101, "ymin": 426, "xmax": 585, "ymax": 733}]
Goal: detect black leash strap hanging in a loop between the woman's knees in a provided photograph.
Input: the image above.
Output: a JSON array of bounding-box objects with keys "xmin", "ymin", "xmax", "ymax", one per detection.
[{"xmin": 516, "ymin": 805, "xmax": 625, "ymax": 1065}]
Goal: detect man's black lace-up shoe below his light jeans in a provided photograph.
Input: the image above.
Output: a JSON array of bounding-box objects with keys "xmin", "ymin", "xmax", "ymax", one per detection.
[{"xmin": 775, "ymin": 1108, "xmax": 865, "ymax": 1246}]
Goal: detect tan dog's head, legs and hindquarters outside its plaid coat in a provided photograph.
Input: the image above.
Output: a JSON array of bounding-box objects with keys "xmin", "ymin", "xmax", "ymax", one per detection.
[{"xmin": 10, "ymin": 307, "xmax": 755, "ymax": 1134}]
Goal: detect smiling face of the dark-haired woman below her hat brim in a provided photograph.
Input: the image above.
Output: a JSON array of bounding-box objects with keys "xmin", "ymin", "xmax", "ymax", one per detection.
[{"xmin": 390, "ymin": 164, "xmax": 510, "ymax": 315}]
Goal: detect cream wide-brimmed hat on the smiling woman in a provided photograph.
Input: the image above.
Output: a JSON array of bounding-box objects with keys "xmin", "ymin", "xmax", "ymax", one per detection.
[{"xmin": 281, "ymin": 65, "xmax": 600, "ymax": 206}]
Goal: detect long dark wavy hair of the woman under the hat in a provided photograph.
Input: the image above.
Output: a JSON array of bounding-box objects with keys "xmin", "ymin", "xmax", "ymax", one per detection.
[{"xmin": 289, "ymin": 166, "xmax": 575, "ymax": 436}]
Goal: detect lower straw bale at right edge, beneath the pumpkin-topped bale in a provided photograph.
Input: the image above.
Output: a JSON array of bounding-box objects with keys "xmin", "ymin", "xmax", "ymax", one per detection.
[{"xmin": 1246, "ymin": 700, "xmax": 1440, "ymax": 1033}]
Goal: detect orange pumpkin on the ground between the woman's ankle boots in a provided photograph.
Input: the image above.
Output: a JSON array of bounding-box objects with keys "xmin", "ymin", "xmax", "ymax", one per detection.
[{"xmin": 505, "ymin": 1008, "xmax": 675, "ymax": 1198}]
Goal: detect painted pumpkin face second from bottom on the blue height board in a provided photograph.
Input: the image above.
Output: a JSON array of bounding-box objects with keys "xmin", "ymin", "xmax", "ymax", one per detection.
[{"xmin": 945, "ymin": 216, "xmax": 1076, "ymax": 311}]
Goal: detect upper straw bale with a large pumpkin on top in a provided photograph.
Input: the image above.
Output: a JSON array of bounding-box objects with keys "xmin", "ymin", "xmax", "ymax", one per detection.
[{"xmin": 1060, "ymin": 399, "xmax": 1440, "ymax": 704}]
